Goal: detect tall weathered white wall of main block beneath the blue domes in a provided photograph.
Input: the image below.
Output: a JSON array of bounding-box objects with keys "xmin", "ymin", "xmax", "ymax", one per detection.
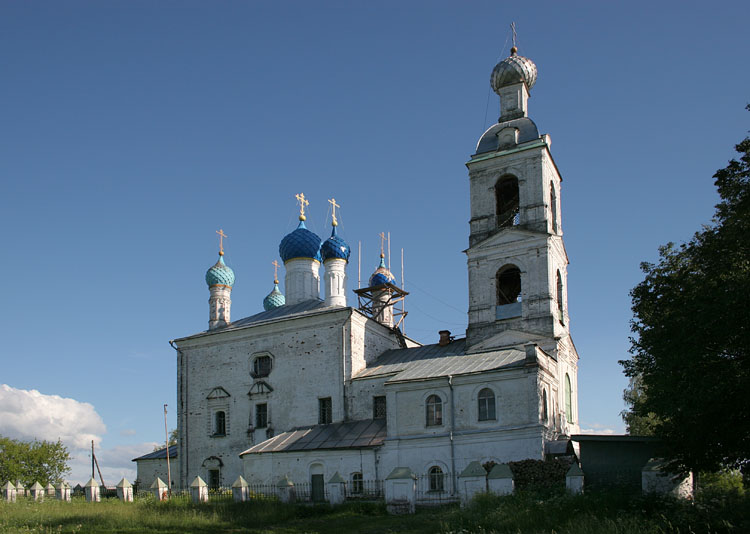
[{"xmin": 180, "ymin": 308, "xmax": 356, "ymax": 485}]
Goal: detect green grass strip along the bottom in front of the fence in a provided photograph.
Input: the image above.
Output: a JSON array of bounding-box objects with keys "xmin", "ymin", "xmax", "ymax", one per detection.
[{"xmin": 0, "ymin": 493, "xmax": 750, "ymax": 534}]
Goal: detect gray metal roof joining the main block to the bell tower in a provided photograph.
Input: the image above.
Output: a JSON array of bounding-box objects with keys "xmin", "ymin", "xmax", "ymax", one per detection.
[{"xmin": 354, "ymin": 339, "xmax": 526, "ymax": 383}]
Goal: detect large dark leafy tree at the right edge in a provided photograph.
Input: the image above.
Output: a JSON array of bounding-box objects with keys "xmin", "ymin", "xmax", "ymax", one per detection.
[{"xmin": 620, "ymin": 118, "xmax": 750, "ymax": 478}]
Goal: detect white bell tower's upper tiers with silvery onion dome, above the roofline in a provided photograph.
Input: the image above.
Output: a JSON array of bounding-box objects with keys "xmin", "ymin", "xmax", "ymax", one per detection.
[{"xmin": 466, "ymin": 46, "xmax": 569, "ymax": 351}]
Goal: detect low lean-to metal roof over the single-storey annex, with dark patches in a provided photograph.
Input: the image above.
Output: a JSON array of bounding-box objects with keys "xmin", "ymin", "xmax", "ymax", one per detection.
[{"xmin": 240, "ymin": 419, "xmax": 386, "ymax": 456}]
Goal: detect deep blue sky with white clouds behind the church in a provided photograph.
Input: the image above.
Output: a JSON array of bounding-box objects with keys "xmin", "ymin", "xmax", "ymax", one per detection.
[{"xmin": 0, "ymin": 0, "xmax": 750, "ymax": 485}]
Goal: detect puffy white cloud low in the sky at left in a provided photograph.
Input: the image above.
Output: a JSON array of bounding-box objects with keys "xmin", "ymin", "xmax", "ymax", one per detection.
[{"xmin": 0, "ymin": 384, "xmax": 107, "ymax": 449}]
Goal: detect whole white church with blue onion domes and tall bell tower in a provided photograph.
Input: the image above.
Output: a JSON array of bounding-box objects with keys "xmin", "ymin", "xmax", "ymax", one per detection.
[{"xmin": 172, "ymin": 47, "xmax": 579, "ymax": 500}]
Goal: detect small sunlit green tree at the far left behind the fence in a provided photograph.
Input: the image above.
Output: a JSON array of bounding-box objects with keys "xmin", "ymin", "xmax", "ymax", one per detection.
[{"xmin": 0, "ymin": 436, "xmax": 70, "ymax": 486}]
